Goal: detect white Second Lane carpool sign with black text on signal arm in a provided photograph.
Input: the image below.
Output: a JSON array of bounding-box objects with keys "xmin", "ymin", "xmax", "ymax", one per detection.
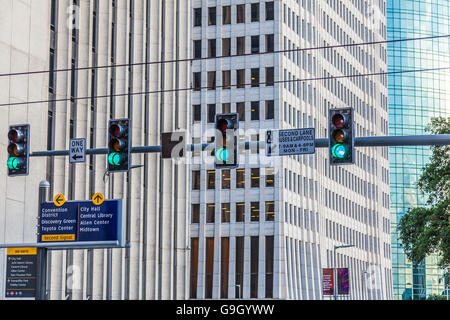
[{"xmin": 266, "ymin": 128, "xmax": 316, "ymax": 157}]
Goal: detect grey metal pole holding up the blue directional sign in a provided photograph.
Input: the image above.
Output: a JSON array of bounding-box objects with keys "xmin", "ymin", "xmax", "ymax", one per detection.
[{"xmin": 36, "ymin": 180, "xmax": 50, "ymax": 300}]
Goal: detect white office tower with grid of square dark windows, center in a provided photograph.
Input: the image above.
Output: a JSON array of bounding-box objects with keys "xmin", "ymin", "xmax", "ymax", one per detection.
[{"xmin": 190, "ymin": 0, "xmax": 392, "ymax": 299}]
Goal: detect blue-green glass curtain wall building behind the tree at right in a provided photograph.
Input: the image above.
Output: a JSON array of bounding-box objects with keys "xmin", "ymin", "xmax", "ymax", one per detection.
[{"xmin": 387, "ymin": 0, "xmax": 450, "ymax": 300}]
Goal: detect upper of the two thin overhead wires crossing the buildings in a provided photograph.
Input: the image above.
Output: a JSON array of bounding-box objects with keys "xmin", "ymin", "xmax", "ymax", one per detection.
[{"xmin": 0, "ymin": 34, "xmax": 450, "ymax": 77}]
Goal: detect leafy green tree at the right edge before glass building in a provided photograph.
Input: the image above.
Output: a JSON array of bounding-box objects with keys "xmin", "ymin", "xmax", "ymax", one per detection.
[{"xmin": 398, "ymin": 117, "xmax": 450, "ymax": 269}]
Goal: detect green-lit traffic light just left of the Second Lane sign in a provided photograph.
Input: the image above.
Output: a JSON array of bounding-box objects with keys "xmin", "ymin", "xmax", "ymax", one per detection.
[{"xmin": 215, "ymin": 113, "xmax": 239, "ymax": 169}]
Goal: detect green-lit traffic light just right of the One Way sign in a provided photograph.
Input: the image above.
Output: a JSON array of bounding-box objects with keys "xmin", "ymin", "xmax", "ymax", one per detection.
[{"xmin": 108, "ymin": 119, "xmax": 131, "ymax": 172}]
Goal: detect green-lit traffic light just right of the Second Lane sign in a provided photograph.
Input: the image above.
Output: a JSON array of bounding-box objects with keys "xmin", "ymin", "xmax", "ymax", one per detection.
[{"xmin": 328, "ymin": 108, "xmax": 355, "ymax": 165}]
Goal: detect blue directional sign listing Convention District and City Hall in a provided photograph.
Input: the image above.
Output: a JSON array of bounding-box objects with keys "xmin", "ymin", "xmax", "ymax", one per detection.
[{"xmin": 39, "ymin": 199, "xmax": 124, "ymax": 245}]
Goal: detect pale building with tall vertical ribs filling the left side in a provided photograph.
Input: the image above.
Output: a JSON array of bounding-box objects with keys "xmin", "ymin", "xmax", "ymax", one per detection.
[{"xmin": 0, "ymin": 0, "xmax": 191, "ymax": 299}]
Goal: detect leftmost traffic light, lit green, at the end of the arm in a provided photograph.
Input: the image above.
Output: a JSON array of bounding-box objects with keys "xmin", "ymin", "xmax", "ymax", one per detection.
[{"xmin": 6, "ymin": 124, "xmax": 30, "ymax": 177}]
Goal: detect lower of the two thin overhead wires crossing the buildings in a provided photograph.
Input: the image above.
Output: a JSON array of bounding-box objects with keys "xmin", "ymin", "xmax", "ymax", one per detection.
[{"xmin": 0, "ymin": 67, "xmax": 450, "ymax": 107}]
